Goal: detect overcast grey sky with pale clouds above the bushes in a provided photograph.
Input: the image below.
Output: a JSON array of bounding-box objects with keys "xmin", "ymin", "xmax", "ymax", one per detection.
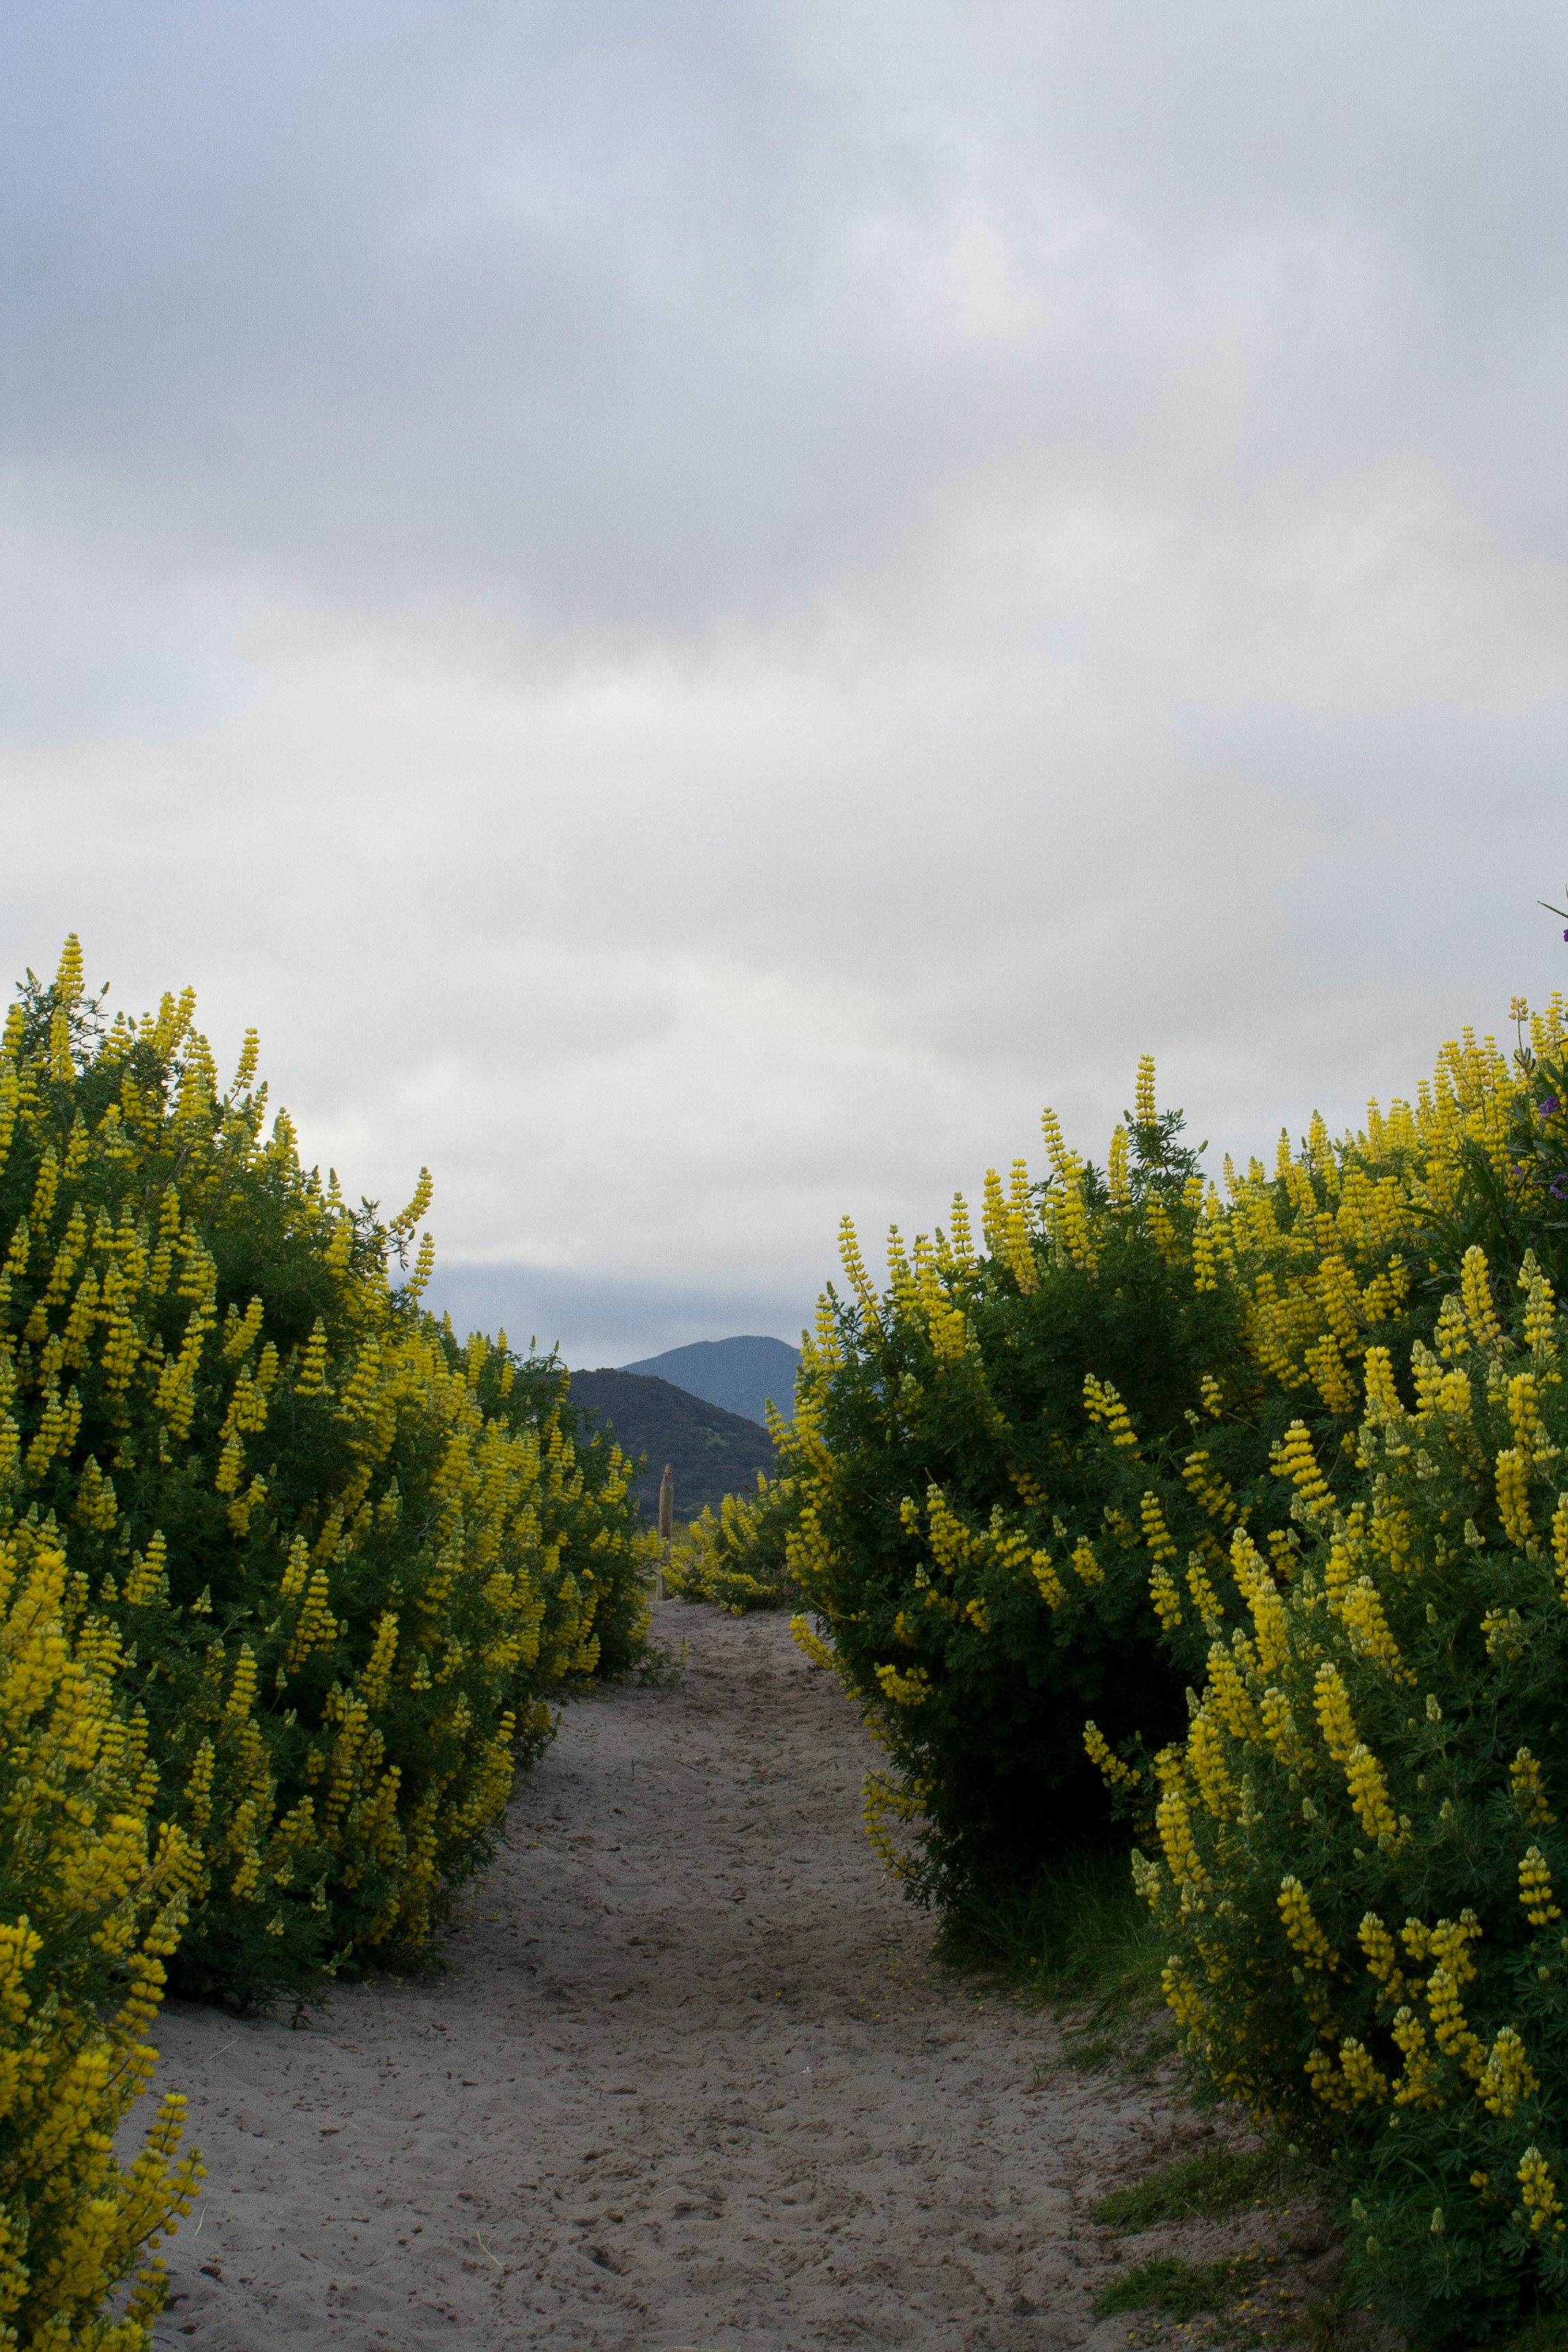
[{"xmin": 0, "ymin": 0, "xmax": 1568, "ymax": 1364}]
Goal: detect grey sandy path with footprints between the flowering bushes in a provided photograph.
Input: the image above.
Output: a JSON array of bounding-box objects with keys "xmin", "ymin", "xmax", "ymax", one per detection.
[{"xmin": 157, "ymin": 1602, "xmax": 1171, "ymax": 2352}]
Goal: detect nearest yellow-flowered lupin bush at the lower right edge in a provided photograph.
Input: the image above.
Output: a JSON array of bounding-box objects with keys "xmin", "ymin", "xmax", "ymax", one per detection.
[{"xmin": 1138, "ymin": 1247, "xmax": 1568, "ymax": 2342}]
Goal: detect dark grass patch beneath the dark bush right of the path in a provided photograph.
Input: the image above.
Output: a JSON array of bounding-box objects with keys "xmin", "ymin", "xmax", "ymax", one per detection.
[{"xmin": 938, "ymin": 1848, "xmax": 1164, "ymax": 2023}]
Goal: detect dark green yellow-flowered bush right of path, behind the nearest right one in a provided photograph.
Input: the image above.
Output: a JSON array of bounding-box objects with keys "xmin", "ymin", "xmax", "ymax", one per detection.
[{"xmin": 783, "ymin": 1063, "xmax": 1439, "ymax": 1910}]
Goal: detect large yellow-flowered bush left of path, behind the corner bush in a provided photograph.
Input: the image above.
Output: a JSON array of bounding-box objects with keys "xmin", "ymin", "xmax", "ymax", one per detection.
[{"xmin": 0, "ymin": 941, "xmax": 647, "ymax": 1999}]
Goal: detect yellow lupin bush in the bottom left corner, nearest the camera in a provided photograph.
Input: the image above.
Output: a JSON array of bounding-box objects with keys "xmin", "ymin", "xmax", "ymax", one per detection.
[{"xmin": 0, "ymin": 1524, "xmax": 202, "ymax": 2352}]
